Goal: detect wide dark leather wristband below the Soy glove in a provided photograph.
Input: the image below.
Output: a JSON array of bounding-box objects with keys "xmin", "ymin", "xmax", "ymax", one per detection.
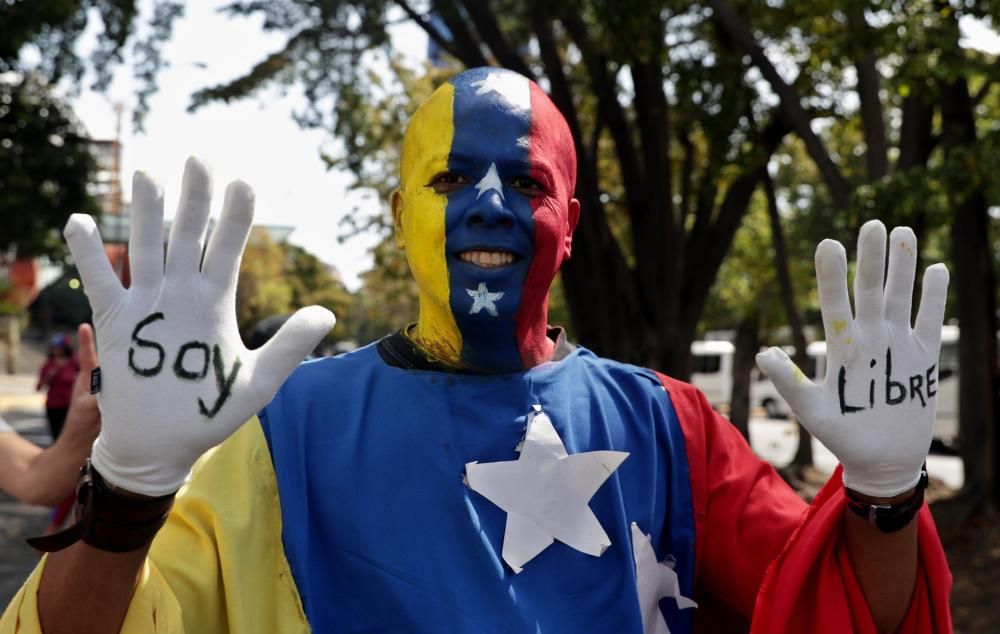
[{"xmin": 27, "ymin": 459, "xmax": 175, "ymax": 553}]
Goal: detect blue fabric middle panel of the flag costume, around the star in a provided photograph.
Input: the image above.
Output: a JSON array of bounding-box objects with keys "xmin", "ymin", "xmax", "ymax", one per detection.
[{"xmin": 260, "ymin": 345, "xmax": 695, "ymax": 634}]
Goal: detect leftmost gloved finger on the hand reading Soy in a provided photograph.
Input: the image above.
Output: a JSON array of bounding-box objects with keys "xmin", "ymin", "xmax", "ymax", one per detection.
[{"xmin": 63, "ymin": 214, "xmax": 125, "ymax": 315}]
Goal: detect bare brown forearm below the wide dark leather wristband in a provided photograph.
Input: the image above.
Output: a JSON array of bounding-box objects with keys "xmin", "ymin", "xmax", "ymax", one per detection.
[{"xmin": 38, "ymin": 542, "xmax": 149, "ymax": 634}]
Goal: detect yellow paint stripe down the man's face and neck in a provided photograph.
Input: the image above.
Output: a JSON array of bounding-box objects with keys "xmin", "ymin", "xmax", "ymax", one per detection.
[{"xmin": 394, "ymin": 83, "xmax": 462, "ymax": 364}]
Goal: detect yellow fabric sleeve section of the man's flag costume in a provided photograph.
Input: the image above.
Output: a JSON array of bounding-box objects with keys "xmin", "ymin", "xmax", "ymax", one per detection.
[{"xmin": 0, "ymin": 418, "xmax": 310, "ymax": 634}]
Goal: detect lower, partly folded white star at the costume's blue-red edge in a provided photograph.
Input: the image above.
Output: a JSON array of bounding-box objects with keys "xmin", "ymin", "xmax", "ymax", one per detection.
[{"xmin": 632, "ymin": 522, "xmax": 698, "ymax": 634}]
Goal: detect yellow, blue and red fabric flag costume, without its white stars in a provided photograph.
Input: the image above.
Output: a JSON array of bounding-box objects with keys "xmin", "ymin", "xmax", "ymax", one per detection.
[{"xmin": 0, "ymin": 338, "xmax": 950, "ymax": 632}]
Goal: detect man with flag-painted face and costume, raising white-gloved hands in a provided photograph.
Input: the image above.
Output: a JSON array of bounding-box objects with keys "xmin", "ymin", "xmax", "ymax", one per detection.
[{"xmin": 0, "ymin": 68, "xmax": 950, "ymax": 633}]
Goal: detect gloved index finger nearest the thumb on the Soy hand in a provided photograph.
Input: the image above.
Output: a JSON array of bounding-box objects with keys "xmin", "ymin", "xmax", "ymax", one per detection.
[{"xmin": 202, "ymin": 181, "xmax": 254, "ymax": 288}]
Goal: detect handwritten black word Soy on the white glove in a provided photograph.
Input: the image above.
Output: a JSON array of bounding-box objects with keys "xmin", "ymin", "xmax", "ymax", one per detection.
[{"xmin": 128, "ymin": 313, "xmax": 243, "ymax": 418}]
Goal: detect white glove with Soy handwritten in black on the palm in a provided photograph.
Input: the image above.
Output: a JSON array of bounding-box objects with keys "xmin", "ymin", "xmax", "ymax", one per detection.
[{"xmin": 65, "ymin": 158, "xmax": 335, "ymax": 496}]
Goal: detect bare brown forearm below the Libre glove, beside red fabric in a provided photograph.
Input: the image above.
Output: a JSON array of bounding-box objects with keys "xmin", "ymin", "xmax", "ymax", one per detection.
[{"xmin": 844, "ymin": 491, "xmax": 917, "ymax": 632}]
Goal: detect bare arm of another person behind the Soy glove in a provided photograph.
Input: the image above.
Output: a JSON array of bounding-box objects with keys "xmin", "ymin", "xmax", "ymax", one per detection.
[{"xmin": 0, "ymin": 324, "xmax": 101, "ymax": 506}]
